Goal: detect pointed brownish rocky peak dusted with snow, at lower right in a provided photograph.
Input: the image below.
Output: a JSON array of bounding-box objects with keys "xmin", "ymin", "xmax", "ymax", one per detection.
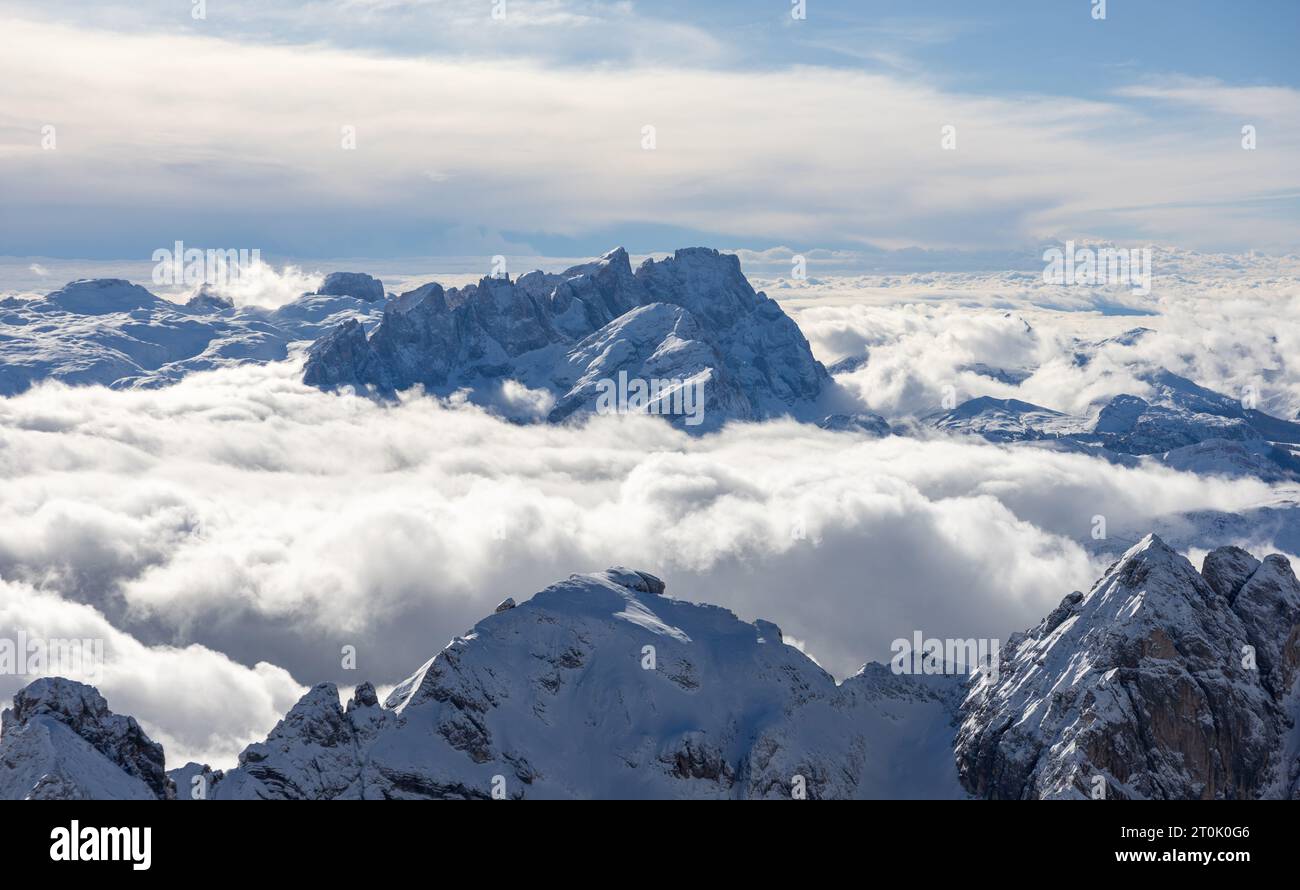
[{"xmin": 956, "ymin": 535, "xmax": 1300, "ymax": 799}]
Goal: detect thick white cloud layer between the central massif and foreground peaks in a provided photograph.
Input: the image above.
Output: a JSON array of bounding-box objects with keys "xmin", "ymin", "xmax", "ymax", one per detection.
[{"xmin": 0, "ymin": 343, "xmax": 1269, "ymax": 747}]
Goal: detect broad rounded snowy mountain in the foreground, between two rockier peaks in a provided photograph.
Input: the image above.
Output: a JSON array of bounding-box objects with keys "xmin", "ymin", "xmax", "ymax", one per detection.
[{"xmin": 215, "ymin": 568, "xmax": 959, "ymax": 799}]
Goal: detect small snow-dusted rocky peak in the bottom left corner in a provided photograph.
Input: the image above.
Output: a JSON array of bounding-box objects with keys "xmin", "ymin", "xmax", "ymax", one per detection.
[{"xmin": 0, "ymin": 677, "xmax": 174, "ymax": 800}]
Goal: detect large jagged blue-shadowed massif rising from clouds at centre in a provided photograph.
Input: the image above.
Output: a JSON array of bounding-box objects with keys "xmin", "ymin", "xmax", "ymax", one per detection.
[{"xmin": 304, "ymin": 248, "xmax": 829, "ymax": 429}]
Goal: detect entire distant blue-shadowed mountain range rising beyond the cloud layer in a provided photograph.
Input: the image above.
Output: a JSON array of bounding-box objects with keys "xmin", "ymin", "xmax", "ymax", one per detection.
[{"xmin": 0, "ymin": 248, "xmax": 1300, "ymax": 482}]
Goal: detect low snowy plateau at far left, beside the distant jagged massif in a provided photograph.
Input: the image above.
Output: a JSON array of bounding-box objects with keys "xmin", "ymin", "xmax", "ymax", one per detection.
[{"xmin": 0, "ymin": 273, "xmax": 384, "ymax": 396}]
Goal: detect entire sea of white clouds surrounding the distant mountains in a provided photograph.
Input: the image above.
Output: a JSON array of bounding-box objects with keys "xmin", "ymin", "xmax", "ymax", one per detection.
[{"xmin": 0, "ymin": 257, "xmax": 1300, "ymax": 767}]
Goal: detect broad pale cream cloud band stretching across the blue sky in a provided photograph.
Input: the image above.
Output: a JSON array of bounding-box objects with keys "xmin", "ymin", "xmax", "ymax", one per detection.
[{"xmin": 0, "ymin": 21, "xmax": 1300, "ymax": 256}]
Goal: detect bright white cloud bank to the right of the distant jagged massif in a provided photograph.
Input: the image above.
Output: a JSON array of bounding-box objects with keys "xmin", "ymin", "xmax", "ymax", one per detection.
[{"xmin": 784, "ymin": 248, "xmax": 1300, "ymax": 418}]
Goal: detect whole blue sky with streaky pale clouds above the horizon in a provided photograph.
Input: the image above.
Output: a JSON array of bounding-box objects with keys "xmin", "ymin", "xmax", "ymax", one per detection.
[{"xmin": 0, "ymin": 0, "xmax": 1300, "ymax": 260}]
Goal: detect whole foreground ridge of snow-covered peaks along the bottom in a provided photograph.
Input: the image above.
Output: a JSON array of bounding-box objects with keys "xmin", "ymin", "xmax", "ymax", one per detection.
[{"xmin": 0, "ymin": 535, "xmax": 1300, "ymax": 799}]
